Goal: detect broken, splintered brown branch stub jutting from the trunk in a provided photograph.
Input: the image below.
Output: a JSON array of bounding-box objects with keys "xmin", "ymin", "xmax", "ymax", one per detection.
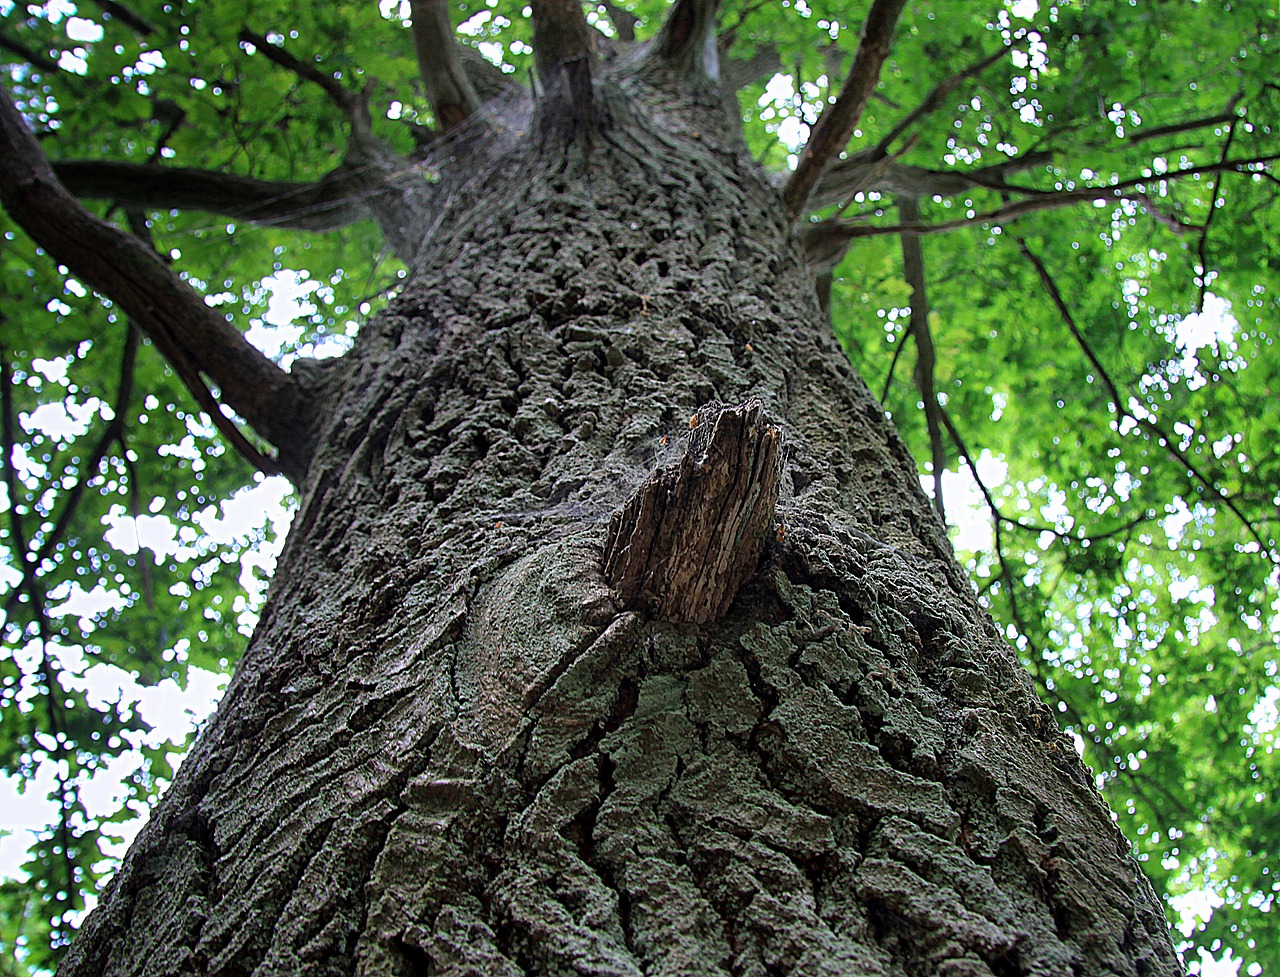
[{"xmin": 604, "ymin": 400, "xmax": 781, "ymax": 624}]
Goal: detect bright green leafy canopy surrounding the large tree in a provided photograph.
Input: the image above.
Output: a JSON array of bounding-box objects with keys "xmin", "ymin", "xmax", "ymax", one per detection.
[{"xmin": 0, "ymin": 0, "xmax": 1280, "ymax": 973}]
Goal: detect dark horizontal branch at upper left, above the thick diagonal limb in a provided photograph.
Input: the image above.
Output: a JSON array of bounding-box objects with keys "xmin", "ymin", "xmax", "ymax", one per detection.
[{"xmin": 52, "ymin": 160, "xmax": 369, "ymax": 230}]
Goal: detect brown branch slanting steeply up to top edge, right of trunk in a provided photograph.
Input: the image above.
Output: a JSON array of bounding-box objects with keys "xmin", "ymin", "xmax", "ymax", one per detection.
[{"xmin": 782, "ymin": 0, "xmax": 906, "ymax": 216}]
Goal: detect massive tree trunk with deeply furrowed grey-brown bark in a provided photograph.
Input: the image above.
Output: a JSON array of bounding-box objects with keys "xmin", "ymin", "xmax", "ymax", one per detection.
[{"xmin": 61, "ymin": 61, "xmax": 1180, "ymax": 977}]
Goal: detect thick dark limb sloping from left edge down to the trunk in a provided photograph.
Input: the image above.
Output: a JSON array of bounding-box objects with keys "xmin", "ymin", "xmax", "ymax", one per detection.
[{"xmin": 0, "ymin": 85, "xmax": 316, "ymax": 480}]
